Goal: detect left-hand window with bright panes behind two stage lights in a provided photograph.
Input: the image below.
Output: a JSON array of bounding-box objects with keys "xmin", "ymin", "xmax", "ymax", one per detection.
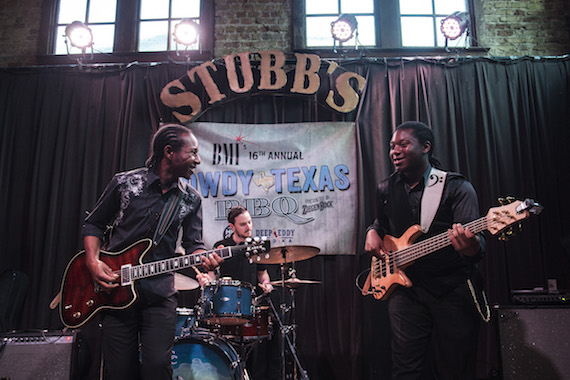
[{"xmin": 43, "ymin": 0, "xmax": 214, "ymax": 55}]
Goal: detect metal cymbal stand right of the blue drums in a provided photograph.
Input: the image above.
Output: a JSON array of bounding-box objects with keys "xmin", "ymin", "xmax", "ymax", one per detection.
[{"xmin": 274, "ymin": 247, "xmax": 309, "ymax": 380}]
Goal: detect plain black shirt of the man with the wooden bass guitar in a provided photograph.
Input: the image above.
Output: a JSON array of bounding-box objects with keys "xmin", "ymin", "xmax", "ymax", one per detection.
[{"xmin": 369, "ymin": 169, "xmax": 485, "ymax": 295}]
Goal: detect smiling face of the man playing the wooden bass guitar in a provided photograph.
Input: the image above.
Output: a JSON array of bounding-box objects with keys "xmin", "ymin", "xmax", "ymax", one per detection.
[{"xmin": 390, "ymin": 128, "xmax": 431, "ymax": 177}]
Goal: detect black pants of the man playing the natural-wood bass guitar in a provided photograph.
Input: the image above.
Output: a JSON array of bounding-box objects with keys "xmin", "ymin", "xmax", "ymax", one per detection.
[{"xmin": 388, "ymin": 283, "xmax": 481, "ymax": 380}]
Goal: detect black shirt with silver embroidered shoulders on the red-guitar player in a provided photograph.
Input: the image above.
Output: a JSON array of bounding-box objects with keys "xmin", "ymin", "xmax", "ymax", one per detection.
[{"xmin": 83, "ymin": 168, "xmax": 205, "ymax": 303}]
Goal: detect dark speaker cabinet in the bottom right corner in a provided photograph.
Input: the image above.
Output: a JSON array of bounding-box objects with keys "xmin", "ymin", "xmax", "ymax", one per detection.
[{"xmin": 497, "ymin": 306, "xmax": 570, "ymax": 380}]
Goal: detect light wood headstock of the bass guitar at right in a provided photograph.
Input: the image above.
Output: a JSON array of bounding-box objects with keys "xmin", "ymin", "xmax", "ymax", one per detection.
[{"xmin": 486, "ymin": 198, "xmax": 543, "ymax": 240}]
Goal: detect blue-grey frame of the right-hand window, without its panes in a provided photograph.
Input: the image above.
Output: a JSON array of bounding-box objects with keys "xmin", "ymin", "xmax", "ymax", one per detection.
[{"xmin": 292, "ymin": 0, "xmax": 480, "ymax": 56}]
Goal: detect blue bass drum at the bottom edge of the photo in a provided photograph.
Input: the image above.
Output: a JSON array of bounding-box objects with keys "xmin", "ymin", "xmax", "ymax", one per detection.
[{"xmin": 172, "ymin": 331, "xmax": 243, "ymax": 380}]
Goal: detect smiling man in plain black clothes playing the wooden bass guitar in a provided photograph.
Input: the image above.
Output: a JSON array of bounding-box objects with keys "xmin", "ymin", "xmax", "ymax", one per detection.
[{"xmin": 365, "ymin": 122, "xmax": 485, "ymax": 380}]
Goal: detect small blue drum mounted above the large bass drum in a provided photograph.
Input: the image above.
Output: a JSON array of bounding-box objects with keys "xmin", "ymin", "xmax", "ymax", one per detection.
[{"xmin": 200, "ymin": 278, "xmax": 253, "ymax": 326}]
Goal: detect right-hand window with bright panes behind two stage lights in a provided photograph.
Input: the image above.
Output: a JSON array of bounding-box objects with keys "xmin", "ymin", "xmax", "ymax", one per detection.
[{"xmin": 294, "ymin": 0, "xmax": 472, "ymax": 49}]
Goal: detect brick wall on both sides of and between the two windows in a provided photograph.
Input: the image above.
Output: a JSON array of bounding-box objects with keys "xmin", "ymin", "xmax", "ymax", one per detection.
[{"xmin": 0, "ymin": 0, "xmax": 570, "ymax": 67}]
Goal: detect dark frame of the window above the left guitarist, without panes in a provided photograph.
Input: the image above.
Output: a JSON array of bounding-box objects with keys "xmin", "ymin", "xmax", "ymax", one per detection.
[{"xmin": 38, "ymin": 0, "xmax": 214, "ymax": 64}]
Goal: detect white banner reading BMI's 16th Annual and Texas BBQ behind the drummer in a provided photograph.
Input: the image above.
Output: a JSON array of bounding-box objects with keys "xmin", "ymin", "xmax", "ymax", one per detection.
[{"xmin": 188, "ymin": 122, "xmax": 358, "ymax": 255}]
